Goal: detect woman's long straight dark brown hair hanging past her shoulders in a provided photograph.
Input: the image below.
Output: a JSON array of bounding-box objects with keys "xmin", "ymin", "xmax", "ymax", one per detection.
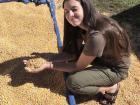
[{"xmin": 63, "ymin": 0, "xmax": 130, "ymax": 59}]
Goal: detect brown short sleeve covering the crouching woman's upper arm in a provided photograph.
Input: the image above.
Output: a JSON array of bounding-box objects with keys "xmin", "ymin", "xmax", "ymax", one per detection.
[{"xmin": 83, "ymin": 31, "xmax": 106, "ymax": 57}]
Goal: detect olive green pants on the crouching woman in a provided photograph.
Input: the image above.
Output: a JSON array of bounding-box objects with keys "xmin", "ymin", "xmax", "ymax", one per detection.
[{"xmin": 66, "ymin": 66, "xmax": 122, "ymax": 95}]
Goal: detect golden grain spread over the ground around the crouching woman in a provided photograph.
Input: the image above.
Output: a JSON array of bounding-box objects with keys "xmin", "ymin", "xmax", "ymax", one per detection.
[{"xmin": 0, "ymin": 2, "xmax": 140, "ymax": 105}]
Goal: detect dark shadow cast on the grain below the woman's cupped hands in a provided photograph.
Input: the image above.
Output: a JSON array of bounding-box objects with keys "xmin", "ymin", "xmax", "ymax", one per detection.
[{"xmin": 0, "ymin": 54, "xmax": 65, "ymax": 95}]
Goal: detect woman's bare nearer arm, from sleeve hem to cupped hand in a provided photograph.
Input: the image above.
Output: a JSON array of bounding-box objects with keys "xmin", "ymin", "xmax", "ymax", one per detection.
[{"xmin": 24, "ymin": 53, "xmax": 95, "ymax": 73}]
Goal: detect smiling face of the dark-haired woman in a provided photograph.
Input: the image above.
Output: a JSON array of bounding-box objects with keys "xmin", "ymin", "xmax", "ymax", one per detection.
[{"xmin": 64, "ymin": 0, "xmax": 84, "ymax": 27}]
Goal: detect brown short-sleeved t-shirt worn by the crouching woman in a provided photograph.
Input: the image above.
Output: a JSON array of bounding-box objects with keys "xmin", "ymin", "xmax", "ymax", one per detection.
[{"xmin": 83, "ymin": 31, "xmax": 130, "ymax": 78}]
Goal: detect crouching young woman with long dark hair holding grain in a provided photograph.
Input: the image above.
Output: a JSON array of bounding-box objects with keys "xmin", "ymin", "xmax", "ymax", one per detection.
[{"xmin": 24, "ymin": 0, "xmax": 130, "ymax": 105}]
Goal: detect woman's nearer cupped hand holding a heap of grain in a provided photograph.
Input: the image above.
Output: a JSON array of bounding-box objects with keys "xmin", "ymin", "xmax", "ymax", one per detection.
[{"xmin": 23, "ymin": 60, "xmax": 52, "ymax": 73}]
